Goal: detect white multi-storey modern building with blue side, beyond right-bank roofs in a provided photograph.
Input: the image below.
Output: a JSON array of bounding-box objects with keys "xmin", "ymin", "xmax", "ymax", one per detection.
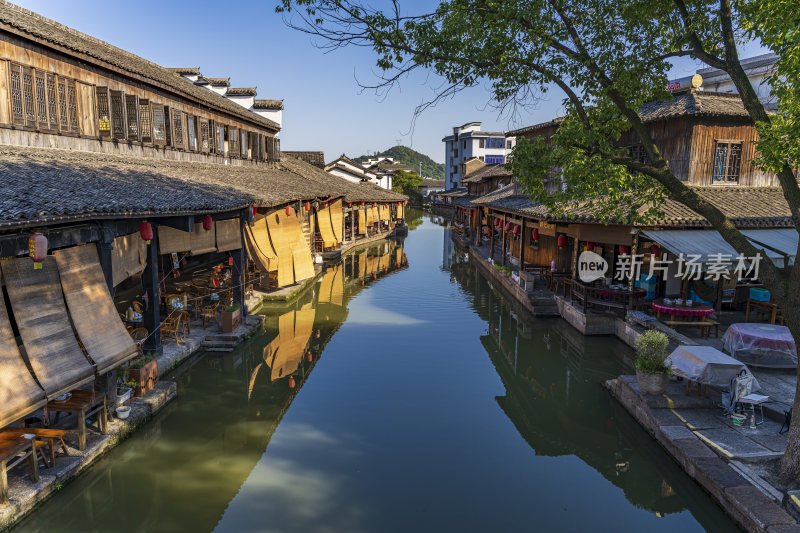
[{"xmin": 442, "ymin": 122, "xmax": 516, "ymax": 190}]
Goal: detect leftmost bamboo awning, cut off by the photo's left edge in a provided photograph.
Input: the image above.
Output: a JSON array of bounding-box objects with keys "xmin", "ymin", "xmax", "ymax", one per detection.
[{"xmin": 0, "ymin": 274, "xmax": 47, "ymax": 427}]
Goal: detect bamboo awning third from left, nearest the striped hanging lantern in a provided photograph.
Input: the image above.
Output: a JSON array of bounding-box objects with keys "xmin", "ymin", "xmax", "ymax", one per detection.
[{"xmin": 53, "ymin": 244, "xmax": 138, "ymax": 374}]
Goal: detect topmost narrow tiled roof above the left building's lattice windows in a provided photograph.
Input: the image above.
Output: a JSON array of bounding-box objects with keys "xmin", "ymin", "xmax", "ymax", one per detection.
[{"xmin": 0, "ymin": 0, "xmax": 280, "ymax": 131}]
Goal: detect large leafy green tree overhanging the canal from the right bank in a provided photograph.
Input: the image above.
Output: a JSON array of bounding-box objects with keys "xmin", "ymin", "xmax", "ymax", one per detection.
[{"xmin": 278, "ymin": 0, "xmax": 800, "ymax": 482}]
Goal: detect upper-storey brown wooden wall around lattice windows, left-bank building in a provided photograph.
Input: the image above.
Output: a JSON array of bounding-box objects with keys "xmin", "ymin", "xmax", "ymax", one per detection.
[{"xmin": 0, "ymin": 31, "xmax": 274, "ymax": 164}]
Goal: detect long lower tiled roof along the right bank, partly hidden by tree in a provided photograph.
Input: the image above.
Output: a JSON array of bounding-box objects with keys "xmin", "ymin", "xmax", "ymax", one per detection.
[{"xmin": 473, "ymin": 185, "xmax": 792, "ymax": 227}]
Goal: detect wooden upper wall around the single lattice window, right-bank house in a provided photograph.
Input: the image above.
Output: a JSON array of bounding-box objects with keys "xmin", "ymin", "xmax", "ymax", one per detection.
[{"xmin": 690, "ymin": 119, "xmax": 780, "ymax": 187}]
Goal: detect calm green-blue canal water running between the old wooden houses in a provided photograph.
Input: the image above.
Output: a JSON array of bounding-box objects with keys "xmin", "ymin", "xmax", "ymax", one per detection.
[{"xmin": 15, "ymin": 210, "xmax": 737, "ymax": 533}]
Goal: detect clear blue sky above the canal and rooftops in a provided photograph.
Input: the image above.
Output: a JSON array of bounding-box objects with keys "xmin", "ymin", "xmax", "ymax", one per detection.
[{"xmin": 15, "ymin": 0, "xmax": 761, "ymax": 162}]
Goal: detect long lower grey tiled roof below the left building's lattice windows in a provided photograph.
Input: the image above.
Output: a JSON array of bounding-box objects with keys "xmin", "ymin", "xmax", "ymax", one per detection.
[{"xmin": 0, "ymin": 146, "xmax": 406, "ymax": 227}]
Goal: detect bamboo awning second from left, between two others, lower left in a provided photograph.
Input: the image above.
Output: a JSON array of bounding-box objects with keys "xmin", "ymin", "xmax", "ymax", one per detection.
[{"xmin": 0, "ymin": 256, "xmax": 94, "ymax": 399}]
